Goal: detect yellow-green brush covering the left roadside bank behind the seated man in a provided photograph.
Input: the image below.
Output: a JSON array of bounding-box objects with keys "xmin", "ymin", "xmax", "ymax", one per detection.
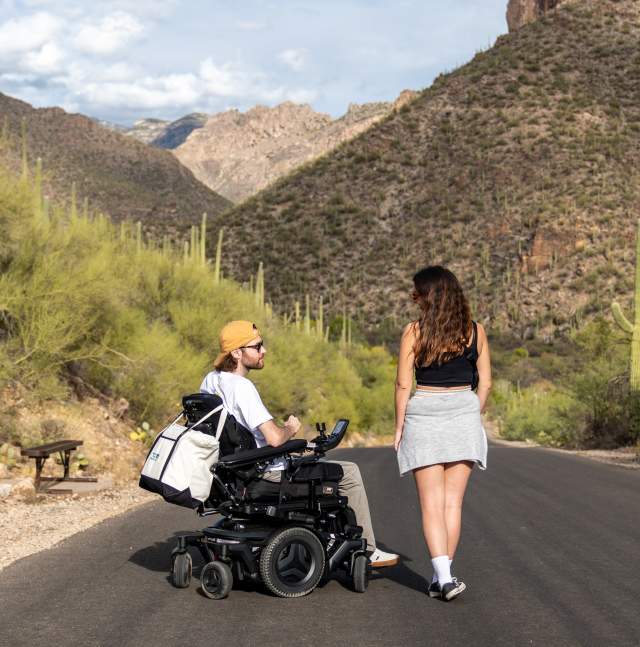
[{"xmin": 0, "ymin": 159, "xmax": 394, "ymax": 454}]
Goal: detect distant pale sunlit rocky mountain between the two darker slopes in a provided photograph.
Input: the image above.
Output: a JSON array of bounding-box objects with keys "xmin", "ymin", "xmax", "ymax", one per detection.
[{"xmin": 174, "ymin": 90, "xmax": 416, "ymax": 202}]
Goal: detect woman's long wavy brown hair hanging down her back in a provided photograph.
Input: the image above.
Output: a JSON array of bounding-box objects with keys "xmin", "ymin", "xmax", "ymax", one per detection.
[{"xmin": 413, "ymin": 265, "xmax": 471, "ymax": 366}]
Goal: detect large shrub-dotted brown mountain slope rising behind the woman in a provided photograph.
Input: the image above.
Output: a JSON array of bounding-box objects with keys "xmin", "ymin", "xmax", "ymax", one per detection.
[{"xmin": 212, "ymin": 0, "xmax": 640, "ymax": 344}]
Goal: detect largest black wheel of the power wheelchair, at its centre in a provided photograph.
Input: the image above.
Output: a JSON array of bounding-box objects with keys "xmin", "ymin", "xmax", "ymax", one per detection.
[{"xmin": 260, "ymin": 527, "xmax": 325, "ymax": 598}]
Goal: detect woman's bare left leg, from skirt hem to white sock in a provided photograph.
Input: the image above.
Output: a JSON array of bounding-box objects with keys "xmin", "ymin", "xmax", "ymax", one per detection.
[{"xmin": 413, "ymin": 465, "xmax": 448, "ymax": 558}]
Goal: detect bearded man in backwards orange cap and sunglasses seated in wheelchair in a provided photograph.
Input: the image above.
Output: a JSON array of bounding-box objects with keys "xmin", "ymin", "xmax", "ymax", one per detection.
[{"xmin": 200, "ymin": 321, "xmax": 398, "ymax": 568}]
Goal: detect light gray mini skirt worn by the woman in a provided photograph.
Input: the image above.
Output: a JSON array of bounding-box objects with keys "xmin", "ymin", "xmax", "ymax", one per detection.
[{"xmin": 398, "ymin": 390, "xmax": 487, "ymax": 476}]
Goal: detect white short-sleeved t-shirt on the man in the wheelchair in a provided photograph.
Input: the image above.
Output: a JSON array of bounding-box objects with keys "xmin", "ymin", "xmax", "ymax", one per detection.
[{"xmin": 200, "ymin": 371, "xmax": 286, "ymax": 471}]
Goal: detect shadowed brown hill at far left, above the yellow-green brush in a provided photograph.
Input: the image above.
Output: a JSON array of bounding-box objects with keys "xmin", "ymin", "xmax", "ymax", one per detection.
[{"xmin": 0, "ymin": 93, "xmax": 229, "ymax": 236}]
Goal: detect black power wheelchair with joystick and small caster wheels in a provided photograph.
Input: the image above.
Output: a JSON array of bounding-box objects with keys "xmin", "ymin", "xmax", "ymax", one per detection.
[{"xmin": 171, "ymin": 394, "xmax": 371, "ymax": 599}]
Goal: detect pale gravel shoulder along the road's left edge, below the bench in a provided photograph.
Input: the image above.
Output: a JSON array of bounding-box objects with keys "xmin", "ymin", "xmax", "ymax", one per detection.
[{"xmin": 0, "ymin": 484, "xmax": 157, "ymax": 571}]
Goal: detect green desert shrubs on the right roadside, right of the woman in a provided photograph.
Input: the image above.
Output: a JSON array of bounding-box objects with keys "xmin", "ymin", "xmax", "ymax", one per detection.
[{"xmin": 491, "ymin": 317, "xmax": 640, "ymax": 448}]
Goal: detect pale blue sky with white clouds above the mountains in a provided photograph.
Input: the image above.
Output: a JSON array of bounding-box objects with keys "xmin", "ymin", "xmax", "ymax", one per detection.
[{"xmin": 0, "ymin": 0, "xmax": 507, "ymax": 125}]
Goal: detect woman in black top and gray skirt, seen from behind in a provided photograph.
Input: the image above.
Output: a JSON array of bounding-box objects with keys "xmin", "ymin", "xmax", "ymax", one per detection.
[{"xmin": 394, "ymin": 265, "xmax": 491, "ymax": 600}]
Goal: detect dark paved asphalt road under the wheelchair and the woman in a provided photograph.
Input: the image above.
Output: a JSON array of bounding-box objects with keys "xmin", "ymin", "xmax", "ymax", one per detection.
[{"xmin": 0, "ymin": 445, "xmax": 640, "ymax": 647}]
